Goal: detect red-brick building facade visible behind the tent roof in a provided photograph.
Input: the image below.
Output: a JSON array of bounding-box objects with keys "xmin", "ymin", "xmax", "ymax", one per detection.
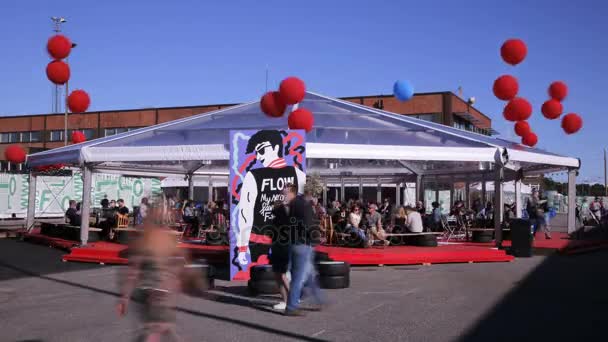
[{"xmin": 0, "ymin": 92, "xmax": 493, "ymax": 172}]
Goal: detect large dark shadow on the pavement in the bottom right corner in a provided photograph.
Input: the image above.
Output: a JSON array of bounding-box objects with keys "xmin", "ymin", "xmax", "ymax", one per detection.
[{"xmin": 458, "ymin": 243, "xmax": 608, "ymax": 342}]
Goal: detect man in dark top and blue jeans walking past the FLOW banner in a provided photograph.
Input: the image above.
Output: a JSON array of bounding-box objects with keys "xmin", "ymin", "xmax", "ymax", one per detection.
[{"xmin": 285, "ymin": 184, "xmax": 324, "ymax": 316}]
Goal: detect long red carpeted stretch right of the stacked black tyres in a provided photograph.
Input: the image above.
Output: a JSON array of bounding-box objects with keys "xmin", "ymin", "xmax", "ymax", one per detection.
[{"xmin": 317, "ymin": 245, "xmax": 513, "ymax": 265}]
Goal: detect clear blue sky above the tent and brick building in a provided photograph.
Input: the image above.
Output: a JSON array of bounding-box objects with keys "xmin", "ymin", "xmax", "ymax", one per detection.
[{"xmin": 0, "ymin": 0, "xmax": 608, "ymax": 181}]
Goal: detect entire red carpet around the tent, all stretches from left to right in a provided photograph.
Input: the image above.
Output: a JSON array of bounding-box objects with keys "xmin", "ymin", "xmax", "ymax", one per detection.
[{"xmin": 33, "ymin": 232, "xmax": 608, "ymax": 265}]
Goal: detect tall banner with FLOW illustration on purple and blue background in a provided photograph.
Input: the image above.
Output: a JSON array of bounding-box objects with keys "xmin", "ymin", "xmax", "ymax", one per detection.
[{"xmin": 229, "ymin": 130, "xmax": 306, "ymax": 280}]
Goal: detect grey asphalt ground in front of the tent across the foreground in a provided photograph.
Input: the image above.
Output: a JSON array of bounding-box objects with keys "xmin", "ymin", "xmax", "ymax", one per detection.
[{"xmin": 0, "ymin": 239, "xmax": 608, "ymax": 342}]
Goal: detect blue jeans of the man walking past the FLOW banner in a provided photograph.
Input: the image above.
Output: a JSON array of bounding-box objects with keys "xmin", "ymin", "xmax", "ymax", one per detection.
[{"xmin": 287, "ymin": 244, "xmax": 324, "ymax": 311}]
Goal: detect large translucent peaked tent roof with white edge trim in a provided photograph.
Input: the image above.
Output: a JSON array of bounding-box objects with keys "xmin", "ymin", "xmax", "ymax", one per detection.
[{"xmin": 28, "ymin": 92, "xmax": 580, "ymax": 175}]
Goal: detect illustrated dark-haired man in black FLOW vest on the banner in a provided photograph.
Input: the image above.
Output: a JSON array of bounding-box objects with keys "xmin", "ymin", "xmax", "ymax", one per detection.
[{"xmin": 232, "ymin": 130, "xmax": 306, "ymax": 276}]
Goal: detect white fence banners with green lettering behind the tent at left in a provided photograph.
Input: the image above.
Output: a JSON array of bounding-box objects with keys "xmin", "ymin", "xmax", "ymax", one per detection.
[{"xmin": 0, "ymin": 172, "xmax": 161, "ymax": 218}]
